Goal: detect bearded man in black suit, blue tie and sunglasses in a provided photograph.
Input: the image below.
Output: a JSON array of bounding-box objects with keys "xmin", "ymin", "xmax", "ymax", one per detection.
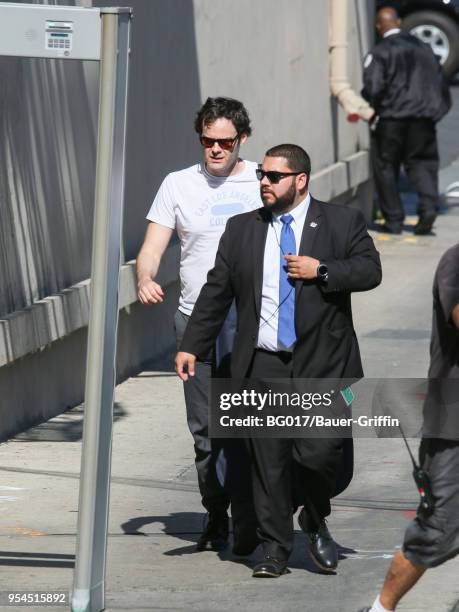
[{"xmin": 176, "ymin": 145, "xmax": 381, "ymax": 577}]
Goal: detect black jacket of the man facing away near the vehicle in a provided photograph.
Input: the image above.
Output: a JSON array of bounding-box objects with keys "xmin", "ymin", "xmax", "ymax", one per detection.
[{"xmin": 362, "ymin": 32, "xmax": 451, "ymax": 121}]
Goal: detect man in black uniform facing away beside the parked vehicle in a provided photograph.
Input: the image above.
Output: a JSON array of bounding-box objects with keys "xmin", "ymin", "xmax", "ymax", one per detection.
[{"xmin": 362, "ymin": 7, "xmax": 451, "ymax": 235}]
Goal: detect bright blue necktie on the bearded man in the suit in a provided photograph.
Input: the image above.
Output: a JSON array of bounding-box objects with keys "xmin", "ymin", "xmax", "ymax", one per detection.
[{"xmin": 277, "ymin": 215, "xmax": 296, "ymax": 349}]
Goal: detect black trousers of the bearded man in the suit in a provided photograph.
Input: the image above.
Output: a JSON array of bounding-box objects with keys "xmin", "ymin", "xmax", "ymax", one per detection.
[{"xmin": 247, "ymin": 350, "xmax": 342, "ymax": 562}]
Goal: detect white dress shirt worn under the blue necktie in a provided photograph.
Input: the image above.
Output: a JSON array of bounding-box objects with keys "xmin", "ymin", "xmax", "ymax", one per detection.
[{"xmin": 257, "ymin": 193, "xmax": 311, "ymax": 351}]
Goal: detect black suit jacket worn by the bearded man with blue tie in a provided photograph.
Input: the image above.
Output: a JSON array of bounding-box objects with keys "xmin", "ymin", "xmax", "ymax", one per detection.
[{"xmin": 180, "ymin": 198, "xmax": 381, "ymax": 378}]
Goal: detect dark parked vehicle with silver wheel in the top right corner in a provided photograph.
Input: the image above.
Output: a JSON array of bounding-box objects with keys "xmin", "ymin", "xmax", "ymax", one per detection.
[{"xmin": 377, "ymin": 0, "xmax": 459, "ymax": 76}]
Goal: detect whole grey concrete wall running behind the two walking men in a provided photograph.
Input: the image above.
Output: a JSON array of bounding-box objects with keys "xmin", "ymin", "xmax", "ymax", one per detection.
[{"xmin": 0, "ymin": 0, "xmax": 372, "ymax": 438}]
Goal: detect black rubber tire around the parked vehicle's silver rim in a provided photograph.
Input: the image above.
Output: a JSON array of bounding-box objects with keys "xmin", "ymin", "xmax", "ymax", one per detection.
[{"xmin": 402, "ymin": 11, "xmax": 459, "ymax": 76}]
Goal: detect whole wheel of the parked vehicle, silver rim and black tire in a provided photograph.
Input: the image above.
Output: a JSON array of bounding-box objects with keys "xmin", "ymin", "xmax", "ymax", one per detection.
[{"xmin": 403, "ymin": 11, "xmax": 459, "ymax": 76}]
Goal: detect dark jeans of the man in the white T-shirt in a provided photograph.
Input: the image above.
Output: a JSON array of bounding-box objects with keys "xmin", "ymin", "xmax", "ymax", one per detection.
[{"xmin": 174, "ymin": 310, "xmax": 229, "ymax": 512}]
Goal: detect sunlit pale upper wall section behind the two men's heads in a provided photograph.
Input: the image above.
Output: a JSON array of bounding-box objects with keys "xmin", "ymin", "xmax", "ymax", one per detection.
[{"xmin": 190, "ymin": 0, "xmax": 368, "ymax": 172}]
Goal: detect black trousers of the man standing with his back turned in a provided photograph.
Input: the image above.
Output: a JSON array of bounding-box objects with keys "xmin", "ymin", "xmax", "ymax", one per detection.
[{"xmin": 372, "ymin": 118, "xmax": 439, "ymax": 227}]
